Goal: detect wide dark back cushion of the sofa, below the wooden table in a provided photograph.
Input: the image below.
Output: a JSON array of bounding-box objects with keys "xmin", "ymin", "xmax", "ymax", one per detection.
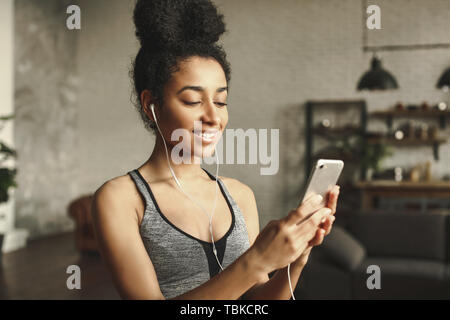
[{"xmin": 348, "ymin": 212, "xmax": 446, "ymax": 262}]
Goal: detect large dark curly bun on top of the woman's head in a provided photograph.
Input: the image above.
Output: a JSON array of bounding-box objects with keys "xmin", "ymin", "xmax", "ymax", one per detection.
[{"xmin": 133, "ymin": 0, "xmax": 225, "ymax": 49}]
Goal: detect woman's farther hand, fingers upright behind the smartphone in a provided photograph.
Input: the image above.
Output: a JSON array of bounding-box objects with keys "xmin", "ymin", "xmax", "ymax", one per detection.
[{"xmin": 295, "ymin": 185, "xmax": 340, "ymax": 266}]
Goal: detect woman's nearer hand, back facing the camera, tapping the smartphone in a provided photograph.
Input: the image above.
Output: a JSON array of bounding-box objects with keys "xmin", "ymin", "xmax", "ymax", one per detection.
[{"xmin": 250, "ymin": 195, "xmax": 332, "ymax": 274}]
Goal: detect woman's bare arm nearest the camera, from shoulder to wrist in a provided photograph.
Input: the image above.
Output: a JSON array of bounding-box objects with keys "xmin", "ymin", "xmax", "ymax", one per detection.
[{"xmin": 92, "ymin": 180, "xmax": 267, "ymax": 299}]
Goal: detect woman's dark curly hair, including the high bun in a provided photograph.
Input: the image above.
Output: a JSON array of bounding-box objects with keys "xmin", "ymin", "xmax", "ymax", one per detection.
[{"xmin": 131, "ymin": 0, "xmax": 231, "ymax": 133}]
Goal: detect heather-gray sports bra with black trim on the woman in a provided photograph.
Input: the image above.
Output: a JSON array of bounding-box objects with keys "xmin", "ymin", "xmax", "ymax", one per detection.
[{"xmin": 128, "ymin": 168, "xmax": 250, "ymax": 299}]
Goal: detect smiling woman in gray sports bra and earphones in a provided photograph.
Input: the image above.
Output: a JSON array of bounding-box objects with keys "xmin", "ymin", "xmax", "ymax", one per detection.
[{"xmin": 93, "ymin": 0, "xmax": 339, "ymax": 299}]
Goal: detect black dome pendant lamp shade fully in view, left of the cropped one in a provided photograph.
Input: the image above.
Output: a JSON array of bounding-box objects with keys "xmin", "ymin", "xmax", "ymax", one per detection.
[{"xmin": 358, "ymin": 56, "xmax": 398, "ymax": 90}]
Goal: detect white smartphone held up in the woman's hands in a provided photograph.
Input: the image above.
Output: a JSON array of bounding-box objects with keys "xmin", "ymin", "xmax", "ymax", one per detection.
[{"xmin": 300, "ymin": 159, "xmax": 344, "ymax": 206}]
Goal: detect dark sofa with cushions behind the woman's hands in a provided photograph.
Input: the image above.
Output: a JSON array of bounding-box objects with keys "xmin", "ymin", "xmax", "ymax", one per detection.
[{"xmin": 295, "ymin": 212, "xmax": 450, "ymax": 299}]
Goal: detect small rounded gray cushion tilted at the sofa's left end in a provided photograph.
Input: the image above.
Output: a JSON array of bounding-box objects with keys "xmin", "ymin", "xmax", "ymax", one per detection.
[{"xmin": 320, "ymin": 225, "xmax": 366, "ymax": 271}]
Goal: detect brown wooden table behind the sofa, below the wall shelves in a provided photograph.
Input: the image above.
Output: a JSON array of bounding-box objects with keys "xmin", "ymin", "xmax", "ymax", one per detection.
[{"xmin": 355, "ymin": 180, "xmax": 450, "ymax": 210}]
